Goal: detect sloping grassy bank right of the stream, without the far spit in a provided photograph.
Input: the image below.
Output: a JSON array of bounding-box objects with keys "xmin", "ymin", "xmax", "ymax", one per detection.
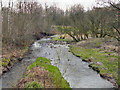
[{"xmin": 70, "ymin": 39, "xmax": 120, "ymax": 86}]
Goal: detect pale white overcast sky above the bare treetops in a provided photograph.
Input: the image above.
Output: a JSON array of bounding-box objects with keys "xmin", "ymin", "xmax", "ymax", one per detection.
[{"xmin": 2, "ymin": 0, "xmax": 119, "ymax": 10}]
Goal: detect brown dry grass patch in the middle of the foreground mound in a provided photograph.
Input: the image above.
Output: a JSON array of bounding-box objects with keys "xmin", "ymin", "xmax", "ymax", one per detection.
[{"xmin": 17, "ymin": 67, "xmax": 55, "ymax": 88}]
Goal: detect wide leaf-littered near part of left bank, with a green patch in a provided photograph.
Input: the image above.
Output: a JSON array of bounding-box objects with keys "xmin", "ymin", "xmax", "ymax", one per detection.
[{"xmin": 1, "ymin": 46, "xmax": 29, "ymax": 73}]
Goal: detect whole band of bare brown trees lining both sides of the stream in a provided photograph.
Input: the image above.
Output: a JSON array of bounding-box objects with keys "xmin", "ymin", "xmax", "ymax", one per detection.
[{"xmin": 2, "ymin": 2, "xmax": 120, "ymax": 46}]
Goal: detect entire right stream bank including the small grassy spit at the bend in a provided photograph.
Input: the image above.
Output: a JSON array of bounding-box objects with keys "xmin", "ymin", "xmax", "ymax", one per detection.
[{"xmin": 53, "ymin": 35, "xmax": 120, "ymax": 88}]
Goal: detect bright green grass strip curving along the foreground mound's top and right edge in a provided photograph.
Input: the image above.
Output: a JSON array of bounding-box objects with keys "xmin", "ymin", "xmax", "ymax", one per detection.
[{"xmin": 27, "ymin": 57, "xmax": 70, "ymax": 88}]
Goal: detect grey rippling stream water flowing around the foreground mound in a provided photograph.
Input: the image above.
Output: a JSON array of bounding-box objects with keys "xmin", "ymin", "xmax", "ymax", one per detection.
[{"xmin": 2, "ymin": 38, "xmax": 113, "ymax": 88}]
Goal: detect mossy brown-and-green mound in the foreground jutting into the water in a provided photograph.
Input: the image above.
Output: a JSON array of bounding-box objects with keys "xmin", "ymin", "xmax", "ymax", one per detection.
[{"xmin": 17, "ymin": 57, "xmax": 70, "ymax": 88}]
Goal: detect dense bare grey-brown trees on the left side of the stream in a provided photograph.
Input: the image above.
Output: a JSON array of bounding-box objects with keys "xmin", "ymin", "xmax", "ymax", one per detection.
[{"xmin": 2, "ymin": 2, "xmax": 64, "ymax": 46}]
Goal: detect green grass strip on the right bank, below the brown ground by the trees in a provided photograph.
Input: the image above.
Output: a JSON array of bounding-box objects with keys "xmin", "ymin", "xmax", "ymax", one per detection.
[{"xmin": 70, "ymin": 45, "xmax": 120, "ymax": 82}]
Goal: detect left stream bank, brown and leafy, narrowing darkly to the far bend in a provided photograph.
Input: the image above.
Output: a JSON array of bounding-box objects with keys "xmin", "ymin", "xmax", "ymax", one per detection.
[{"xmin": 0, "ymin": 33, "xmax": 53, "ymax": 76}]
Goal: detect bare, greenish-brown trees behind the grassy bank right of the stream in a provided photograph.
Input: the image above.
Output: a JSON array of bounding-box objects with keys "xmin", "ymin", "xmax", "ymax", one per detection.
[{"xmin": 56, "ymin": 4, "xmax": 120, "ymax": 41}]
